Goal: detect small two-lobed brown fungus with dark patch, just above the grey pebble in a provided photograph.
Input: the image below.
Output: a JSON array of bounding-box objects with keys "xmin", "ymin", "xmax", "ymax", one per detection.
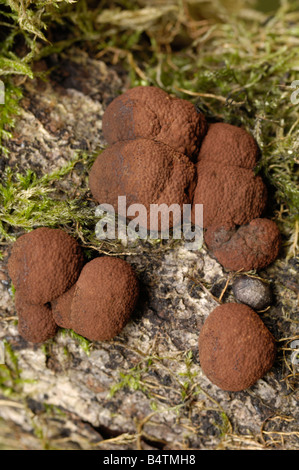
[{"xmin": 205, "ymin": 218, "xmax": 281, "ymax": 271}]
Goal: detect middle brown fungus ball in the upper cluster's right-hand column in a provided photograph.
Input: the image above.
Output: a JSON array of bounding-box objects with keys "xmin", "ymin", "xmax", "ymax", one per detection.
[{"xmin": 192, "ymin": 161, "xmax": 267, "ymax": 228}]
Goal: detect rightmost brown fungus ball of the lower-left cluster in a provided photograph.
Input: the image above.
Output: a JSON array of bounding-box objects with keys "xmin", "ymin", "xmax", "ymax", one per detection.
[{"xmin": 70, "ymin": 256, "xmax": 139, "ymax": 341}]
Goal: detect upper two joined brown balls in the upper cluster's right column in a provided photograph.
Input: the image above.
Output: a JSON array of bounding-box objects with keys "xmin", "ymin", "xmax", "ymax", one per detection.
[{"xmin": 193, "ymin": 123, "xmax": 267, "ymax": 228}]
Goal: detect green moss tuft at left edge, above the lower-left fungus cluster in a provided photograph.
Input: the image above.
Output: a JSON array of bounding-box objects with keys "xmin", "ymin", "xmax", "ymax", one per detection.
[{"xmin": 0, "ymin": 155, "xmax": 94, "ymax": 241}]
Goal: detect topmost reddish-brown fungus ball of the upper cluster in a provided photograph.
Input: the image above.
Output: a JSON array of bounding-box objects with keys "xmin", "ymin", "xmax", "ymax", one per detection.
[{"xmin": 102, "ymin": 86, "xmax": 207, "ymax": 162}]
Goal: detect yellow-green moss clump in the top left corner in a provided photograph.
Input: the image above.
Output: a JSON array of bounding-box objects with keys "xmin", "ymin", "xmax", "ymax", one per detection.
[{"xmin": 0, "ymin": 0, "xmax": 78, "ymax": 151}]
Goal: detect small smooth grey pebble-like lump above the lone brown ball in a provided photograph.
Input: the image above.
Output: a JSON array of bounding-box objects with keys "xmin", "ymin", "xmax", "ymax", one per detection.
[{"xmin": 232, "ymin": 276, "xmax": 272, "ymax": 310}]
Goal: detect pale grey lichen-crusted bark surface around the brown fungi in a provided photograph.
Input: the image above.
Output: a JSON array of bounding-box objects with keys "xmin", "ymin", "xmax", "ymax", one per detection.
[{"xmin": 0, "ymin": 51, "xmax": 299, "ymax": 450}]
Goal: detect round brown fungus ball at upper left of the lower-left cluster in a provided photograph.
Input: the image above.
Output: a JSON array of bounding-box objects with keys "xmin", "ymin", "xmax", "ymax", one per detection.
[{"xmin": 8, "ymin": 227, "xmax": 83, "ymax": 304}]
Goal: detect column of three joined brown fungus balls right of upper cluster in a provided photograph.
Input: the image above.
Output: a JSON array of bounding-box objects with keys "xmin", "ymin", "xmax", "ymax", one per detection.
[{"xmin": 192, "ymin": 123, "xmax": 280, "ymax": 271}]
